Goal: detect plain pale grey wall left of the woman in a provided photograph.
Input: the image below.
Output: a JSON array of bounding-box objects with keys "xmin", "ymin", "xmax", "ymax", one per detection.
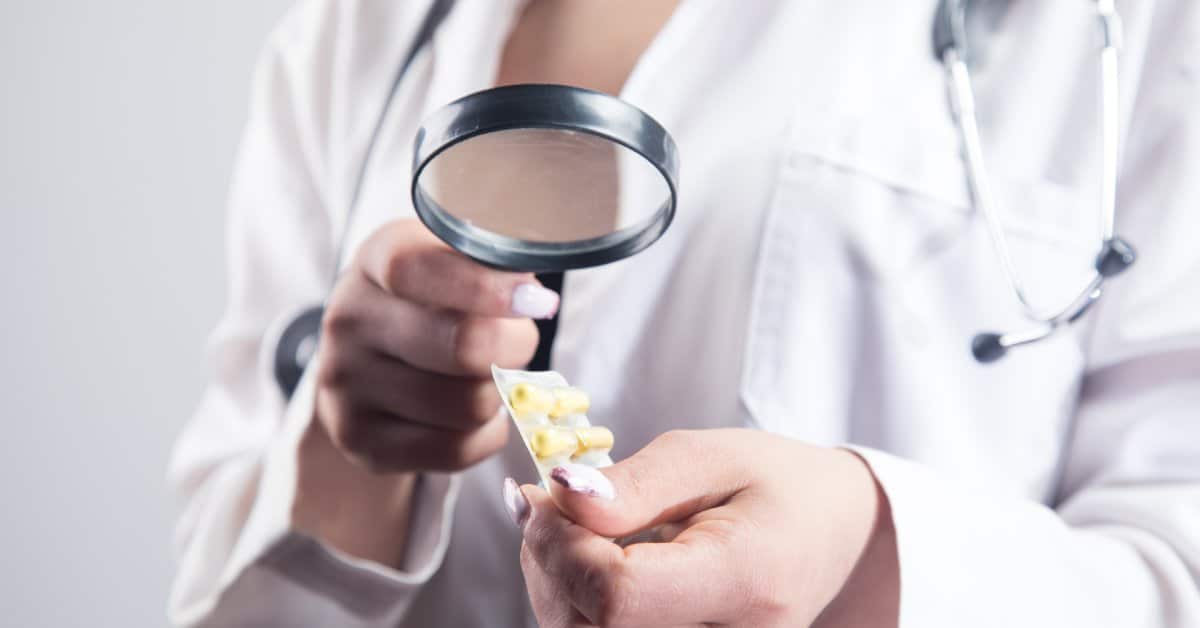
[{"xmin": 0, "ymin": 0, "xmax": 290, "ymax": 628}]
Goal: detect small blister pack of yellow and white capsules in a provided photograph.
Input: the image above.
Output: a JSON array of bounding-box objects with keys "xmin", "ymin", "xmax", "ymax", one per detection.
[{"xmin": 492, "ymin": 365, "xmax": 613, "ymax": 486}]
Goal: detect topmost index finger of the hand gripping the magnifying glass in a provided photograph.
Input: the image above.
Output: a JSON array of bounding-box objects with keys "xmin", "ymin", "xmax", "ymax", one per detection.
[{"xmin": 359, "ymin": 220, "xmax": 558, "ymax": 318}]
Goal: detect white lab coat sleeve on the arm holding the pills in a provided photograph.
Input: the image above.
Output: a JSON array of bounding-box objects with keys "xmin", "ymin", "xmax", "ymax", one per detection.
[{"xmin": 856, "ymin": 1, "xmax": 1200, "ymax": 628}]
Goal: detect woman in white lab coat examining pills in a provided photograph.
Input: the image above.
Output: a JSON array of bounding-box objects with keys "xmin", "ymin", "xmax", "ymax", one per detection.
[{"xmin": 170, "ymin": 0, "xmax": 1200, "ymax": 628}]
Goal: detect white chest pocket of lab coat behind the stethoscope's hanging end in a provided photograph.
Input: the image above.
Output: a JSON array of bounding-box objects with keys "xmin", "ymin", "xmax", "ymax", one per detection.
[{"xmin": 740, "ymin": 114, "xmax": 1096, "ymax": 487}]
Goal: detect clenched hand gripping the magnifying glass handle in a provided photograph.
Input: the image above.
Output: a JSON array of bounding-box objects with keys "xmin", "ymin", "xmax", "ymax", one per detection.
[{"xmin": 317, "ymin": 220, "xmax": 558, "ymax": 471}]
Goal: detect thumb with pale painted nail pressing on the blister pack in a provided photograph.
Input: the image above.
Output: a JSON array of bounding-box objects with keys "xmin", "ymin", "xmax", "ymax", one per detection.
[{"xmin": 550, "ymin": 430, "xmax": 749, "ymax": 538}]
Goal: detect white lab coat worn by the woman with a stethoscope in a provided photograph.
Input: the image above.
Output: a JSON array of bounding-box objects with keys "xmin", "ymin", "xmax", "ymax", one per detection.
[{"xmin": 170, "ymin": 0, "xmax": 1200, "ymax": 628}]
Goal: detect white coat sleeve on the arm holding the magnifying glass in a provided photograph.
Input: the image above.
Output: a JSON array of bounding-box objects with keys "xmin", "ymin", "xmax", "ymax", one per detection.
[{"xmin": 168, "ymin": 1, "xmax": 457, "ymax": 626}]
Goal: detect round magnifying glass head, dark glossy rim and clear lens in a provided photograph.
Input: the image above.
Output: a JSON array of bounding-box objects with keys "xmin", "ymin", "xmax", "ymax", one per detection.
[{"xmin": 412, "ymin": 84, "xmax": 679, "ymax": 273}]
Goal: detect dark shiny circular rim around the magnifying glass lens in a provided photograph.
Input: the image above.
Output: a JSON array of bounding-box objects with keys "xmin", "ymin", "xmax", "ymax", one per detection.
[{"xmin": 412, "ymin": 84, "xmax": 679, "ymax": 273}]
